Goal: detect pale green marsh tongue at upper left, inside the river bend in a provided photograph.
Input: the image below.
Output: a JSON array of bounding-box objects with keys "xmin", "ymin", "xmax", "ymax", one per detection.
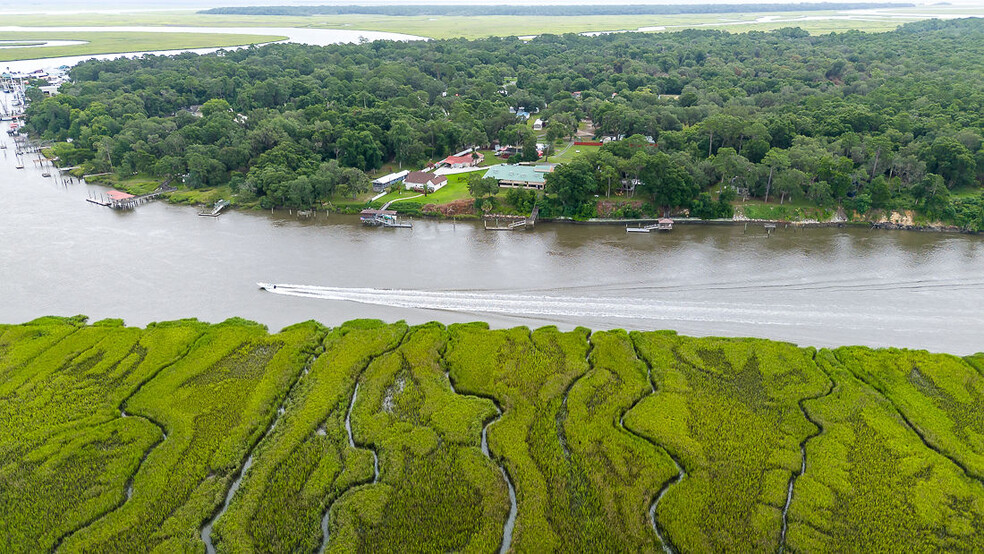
[{"xmin": 0, "ymin": 31, "xmax": 286, "ymax": 61}]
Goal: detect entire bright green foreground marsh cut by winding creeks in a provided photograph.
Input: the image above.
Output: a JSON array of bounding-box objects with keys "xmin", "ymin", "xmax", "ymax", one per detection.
[{"xmin": 0, "ymin": 317, "xmax": 984, "ymax": 554}]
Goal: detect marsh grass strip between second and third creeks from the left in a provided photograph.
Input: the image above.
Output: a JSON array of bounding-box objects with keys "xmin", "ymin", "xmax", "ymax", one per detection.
[{"xmin": 214, "ymin": 321, "xmax": 407, "ymax": 552}]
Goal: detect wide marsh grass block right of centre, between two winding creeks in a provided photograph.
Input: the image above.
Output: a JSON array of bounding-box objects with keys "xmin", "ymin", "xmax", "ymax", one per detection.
[{"xmin": 631, "ymin": 332, "xmax": 828, "ymax": 552}]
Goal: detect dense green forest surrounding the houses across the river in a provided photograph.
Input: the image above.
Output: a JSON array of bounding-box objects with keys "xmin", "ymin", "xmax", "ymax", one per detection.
[{"xmin": 21, "ymin": 19, "xmax": 984, "ymax": 226}]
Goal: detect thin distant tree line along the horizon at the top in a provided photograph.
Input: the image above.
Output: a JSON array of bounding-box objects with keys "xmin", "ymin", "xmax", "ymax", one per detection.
[{"xmin": 198, "ymin": 2, "xmax": 914, "ymax": 17}]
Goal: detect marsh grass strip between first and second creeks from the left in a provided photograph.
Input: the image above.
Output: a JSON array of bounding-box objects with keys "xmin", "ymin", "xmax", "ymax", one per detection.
[{"xmin": 58, "ymin": 320, "xmax": 320, "ymax": 552}]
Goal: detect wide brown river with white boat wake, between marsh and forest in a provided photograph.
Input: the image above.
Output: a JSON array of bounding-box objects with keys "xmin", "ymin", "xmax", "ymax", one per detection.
[{"xmin": 0, "ymin": 131, "xmax": 984, "ymax": 354}]
